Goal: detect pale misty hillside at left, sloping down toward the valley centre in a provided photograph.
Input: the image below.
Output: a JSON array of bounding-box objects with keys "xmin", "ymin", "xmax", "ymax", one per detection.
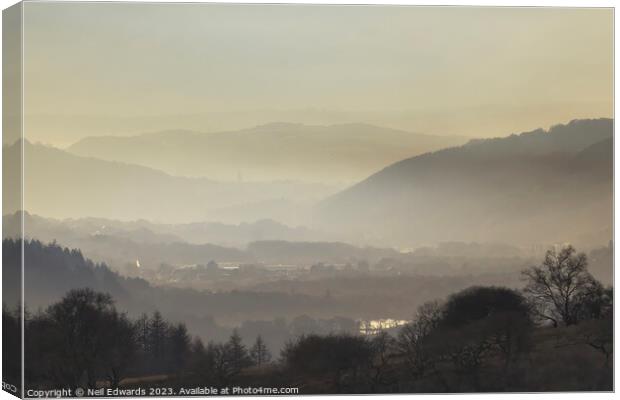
[{"xmin": 2, "ymin": 141, "xmax": 338, "ymax": 224}]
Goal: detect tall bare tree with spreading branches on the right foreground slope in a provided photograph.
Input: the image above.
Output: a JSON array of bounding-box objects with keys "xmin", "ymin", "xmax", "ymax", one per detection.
[{"xmin": 522, "ymin": 246, "xmax": 600, "ymax": 326}]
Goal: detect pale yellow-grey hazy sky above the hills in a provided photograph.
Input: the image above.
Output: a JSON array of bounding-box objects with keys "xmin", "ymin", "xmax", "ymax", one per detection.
[{"xmin": 24, "ymin": 3, "xmax": 613, "ymax": 145}]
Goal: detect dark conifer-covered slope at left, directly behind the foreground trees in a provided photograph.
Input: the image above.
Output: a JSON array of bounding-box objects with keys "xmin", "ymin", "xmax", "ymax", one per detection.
[{"xmin": 2, "ymin": 239, "xmax": 342, "ymax": 337}]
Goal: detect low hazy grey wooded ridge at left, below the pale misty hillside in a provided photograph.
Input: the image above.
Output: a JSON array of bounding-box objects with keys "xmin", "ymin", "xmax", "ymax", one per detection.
[{"xmin": 2, "ymin": 213, "xmax": 398, "ymax": 273}]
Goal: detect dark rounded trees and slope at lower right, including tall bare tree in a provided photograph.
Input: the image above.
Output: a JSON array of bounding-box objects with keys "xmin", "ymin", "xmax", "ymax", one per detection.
[{"xmin": 283, "ymin": 246, "xmax": 613, "ymax": 393}]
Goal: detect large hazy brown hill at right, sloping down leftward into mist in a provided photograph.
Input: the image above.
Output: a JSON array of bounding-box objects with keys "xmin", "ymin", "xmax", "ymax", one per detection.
[{"xmin": 317, "ymin": 119, "xmax": 613, "ymax": 245}]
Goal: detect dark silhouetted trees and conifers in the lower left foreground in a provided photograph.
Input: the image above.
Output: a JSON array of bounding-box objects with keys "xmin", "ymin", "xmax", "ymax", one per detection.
[{"xmin": 9, "ymin": 288, "xmax": 271, "ymax": 388}]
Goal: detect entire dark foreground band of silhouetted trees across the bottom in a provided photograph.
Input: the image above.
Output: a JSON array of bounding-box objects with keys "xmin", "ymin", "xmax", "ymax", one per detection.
[{"xmin": 3, "ymin": 247, "xmax": 613, "ymax": 393}]
